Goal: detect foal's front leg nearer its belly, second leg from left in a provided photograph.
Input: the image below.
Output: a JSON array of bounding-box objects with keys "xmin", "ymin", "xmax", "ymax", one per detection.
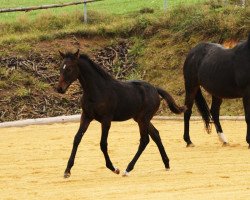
[{"xmin": 100, "ymin": 121, "xmax": 120, "ymax": 174}]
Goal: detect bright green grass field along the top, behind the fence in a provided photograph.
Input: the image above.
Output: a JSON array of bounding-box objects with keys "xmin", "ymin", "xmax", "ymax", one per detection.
[{"xmin": 0, "ymin": 0, "xmax": 204, "ymax": 22}]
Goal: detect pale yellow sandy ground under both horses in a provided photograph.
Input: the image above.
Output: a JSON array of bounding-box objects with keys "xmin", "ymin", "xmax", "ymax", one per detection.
[{"xmin": 0, "ymin": 120, "xmax": 250, "ymax": 200}]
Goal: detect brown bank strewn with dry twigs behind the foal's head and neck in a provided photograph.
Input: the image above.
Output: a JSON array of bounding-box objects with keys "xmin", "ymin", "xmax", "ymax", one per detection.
[{"xmin": 0, "ymin": 40, "xmax": 137, "ymax": 121}]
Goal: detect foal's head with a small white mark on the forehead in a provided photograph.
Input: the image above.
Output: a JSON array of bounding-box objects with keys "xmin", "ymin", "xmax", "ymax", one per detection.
[{"xmin": 57, "ymin": 49, "xmax": 80, "ymax": 94}]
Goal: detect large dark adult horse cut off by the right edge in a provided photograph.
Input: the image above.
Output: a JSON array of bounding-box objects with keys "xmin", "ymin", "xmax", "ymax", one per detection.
[{"xmin": 183, "ymin": 34, "xmax": 250, "ymax": 148}]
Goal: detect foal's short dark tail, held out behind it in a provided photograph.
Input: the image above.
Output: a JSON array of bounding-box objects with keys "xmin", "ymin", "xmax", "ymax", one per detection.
[{"xmin": 156, "ymin": 88, "xmax": 186, "ymax": 114}]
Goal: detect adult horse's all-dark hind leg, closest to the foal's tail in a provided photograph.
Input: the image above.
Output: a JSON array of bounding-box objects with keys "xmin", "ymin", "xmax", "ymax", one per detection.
[{"xmin": 183, "ymin": 87, "xmax": 198, "ymax": 147}]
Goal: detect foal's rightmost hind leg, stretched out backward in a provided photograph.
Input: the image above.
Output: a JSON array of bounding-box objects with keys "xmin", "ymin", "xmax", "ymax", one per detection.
[{"xmin": 149, "ymin": 123, "xmax": 170, "ymax": 170}]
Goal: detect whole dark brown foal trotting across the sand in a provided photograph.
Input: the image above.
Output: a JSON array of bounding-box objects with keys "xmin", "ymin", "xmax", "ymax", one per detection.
[{"xmin": 57, "ymin": 50, "xmax": 185, "ymax": 178}]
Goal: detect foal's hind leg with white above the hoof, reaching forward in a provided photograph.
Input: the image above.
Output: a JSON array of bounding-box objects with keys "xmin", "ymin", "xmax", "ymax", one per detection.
[{"xmin": 123, "ymin": 122, "xmax": 149, "ymax": 176}]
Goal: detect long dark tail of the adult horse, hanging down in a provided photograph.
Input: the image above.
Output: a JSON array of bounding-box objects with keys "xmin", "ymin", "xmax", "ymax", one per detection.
[{"xmin": 195, "ymin": 88, "xmax": 213, "ymax": 133}]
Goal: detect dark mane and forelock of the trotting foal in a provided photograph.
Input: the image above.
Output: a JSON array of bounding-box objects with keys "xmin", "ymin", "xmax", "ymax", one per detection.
[{"xmin": 65, "ymin": 52, "xmax": 114, "ymax": 80}]
